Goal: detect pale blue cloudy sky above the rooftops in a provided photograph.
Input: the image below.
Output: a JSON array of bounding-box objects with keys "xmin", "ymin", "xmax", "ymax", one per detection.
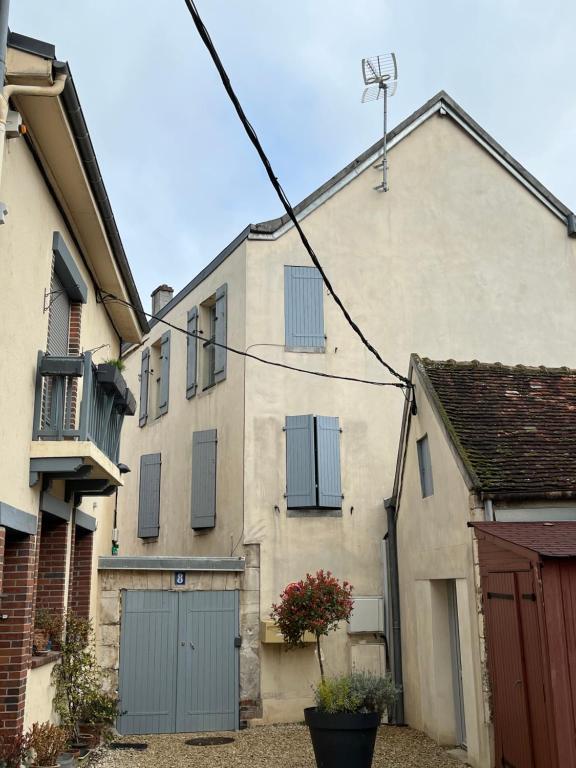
[{"xmin": 10, "ymin": 0, "xmax": 576, "ymax": 307}]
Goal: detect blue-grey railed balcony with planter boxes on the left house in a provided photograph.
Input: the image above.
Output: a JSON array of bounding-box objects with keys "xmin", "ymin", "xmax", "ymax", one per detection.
[{"xmin": 30, "ymin": 352, "xmax": 136, "ymax": 499}]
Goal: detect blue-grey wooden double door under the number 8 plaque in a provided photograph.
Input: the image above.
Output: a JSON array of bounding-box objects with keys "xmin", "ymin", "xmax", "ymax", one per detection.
[{"xmin": 117, "ymin": 590, "xmax": 239, "ymax": 734}]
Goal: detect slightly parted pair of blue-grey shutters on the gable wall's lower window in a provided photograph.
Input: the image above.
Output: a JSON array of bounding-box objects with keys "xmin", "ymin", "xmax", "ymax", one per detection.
[{"xmin": 285, "ymin": 415, "xmax": 342, "ymax": 509}]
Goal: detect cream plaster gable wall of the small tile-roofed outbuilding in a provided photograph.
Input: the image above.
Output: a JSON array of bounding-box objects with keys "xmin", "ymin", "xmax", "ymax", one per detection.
[{"xmin": 398, "ymin": 381, "xmax": 491, "ymax": 768}]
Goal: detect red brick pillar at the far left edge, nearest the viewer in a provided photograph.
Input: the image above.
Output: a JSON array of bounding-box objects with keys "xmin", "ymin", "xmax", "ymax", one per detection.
[{"xmin": 0, "ymin": 534, "xmax": 36, "ymax": 734}]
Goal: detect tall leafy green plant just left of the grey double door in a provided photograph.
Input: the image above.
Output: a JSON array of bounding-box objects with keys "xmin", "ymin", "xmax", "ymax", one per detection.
[{"xmin": 52, "ymin": 613, "xmax": 102, "ymax": 751}]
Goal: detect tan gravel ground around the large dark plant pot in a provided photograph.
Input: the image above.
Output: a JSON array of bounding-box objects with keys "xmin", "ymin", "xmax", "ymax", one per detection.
[{"xmin": 91, "ymin": 725, "xmax": 462, "ymax": 768}]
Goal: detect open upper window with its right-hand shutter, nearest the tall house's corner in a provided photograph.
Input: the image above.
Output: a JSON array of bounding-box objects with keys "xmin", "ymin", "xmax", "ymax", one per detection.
[{"xmin": 200, "ymin": 285, "xmax": 228, "ymax": 389}]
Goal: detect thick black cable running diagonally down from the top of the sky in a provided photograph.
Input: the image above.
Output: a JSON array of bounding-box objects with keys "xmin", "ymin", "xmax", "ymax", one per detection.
[{"xmin": 184, "ymin": 0, "xmax": 412, "ymax": 389}]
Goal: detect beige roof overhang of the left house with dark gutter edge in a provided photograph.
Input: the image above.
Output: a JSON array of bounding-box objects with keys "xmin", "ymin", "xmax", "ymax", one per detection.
[{"xmin": 6, "ymin": 34, "xmax": 148, "ymax": 342}]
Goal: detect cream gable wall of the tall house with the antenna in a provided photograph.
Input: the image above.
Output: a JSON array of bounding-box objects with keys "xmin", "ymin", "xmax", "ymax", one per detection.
[{"xmin": 245, "ymin": 116, "xmax": 576, "ymax": 717}]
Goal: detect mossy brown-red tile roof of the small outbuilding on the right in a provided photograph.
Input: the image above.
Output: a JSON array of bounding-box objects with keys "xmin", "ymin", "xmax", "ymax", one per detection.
[{"xmin": 419, "ymin": 359, "xmax": 576, "ymax": 496}]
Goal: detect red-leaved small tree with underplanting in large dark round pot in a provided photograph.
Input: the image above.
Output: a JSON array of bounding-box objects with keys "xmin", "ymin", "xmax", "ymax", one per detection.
[{"xmin": 272, "ymin": 570, "xmax": 396, "ymax": 768}]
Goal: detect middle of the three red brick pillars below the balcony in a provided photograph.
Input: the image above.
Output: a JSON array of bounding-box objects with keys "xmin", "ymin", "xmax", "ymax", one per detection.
[{"xmin": 36, "ymin": 513, "xmax": 68, "ymax": 615}]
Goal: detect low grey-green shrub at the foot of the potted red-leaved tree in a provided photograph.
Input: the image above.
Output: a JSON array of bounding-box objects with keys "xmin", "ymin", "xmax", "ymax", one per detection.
[{"xmin": 314, "ymin": 672, "xmax": 398, "ymax": 714}]
